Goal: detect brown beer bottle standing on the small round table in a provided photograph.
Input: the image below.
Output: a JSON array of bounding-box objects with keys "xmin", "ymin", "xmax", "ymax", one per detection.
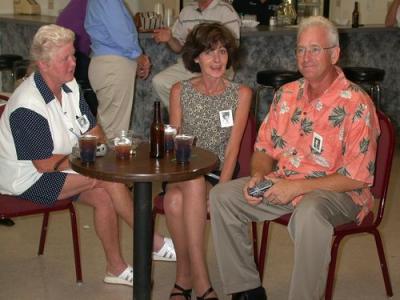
[{"xmin": 150, "ymin": 101, "xmax": 164, "ymax": 158}]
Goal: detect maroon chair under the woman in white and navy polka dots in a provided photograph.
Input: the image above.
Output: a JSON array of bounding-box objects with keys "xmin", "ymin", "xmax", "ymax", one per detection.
[{"xmin": 0, "ymin": 99, "xmax": 82, "ymax": 283}]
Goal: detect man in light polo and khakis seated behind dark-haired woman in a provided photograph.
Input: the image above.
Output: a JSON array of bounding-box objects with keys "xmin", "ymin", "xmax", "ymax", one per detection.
[{"xmin": 152, "ymin": 0, "xmax": 240, "ymax": 108}]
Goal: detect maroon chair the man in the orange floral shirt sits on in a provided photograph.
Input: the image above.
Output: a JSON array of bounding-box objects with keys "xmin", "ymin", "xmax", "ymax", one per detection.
[{"xmin": 258, "ymin": 111, "xmax": 395, "ymax": 300}]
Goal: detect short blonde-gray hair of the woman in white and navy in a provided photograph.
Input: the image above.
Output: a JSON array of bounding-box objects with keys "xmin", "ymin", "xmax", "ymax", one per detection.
[{"xmin": 30, "ymin": 24, "xmax": 75, "ymax": 61}]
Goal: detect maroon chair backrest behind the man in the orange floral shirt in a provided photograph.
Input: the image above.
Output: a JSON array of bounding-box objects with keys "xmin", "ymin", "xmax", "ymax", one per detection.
[{"xmin": 371, "ymin": 110, "xmax": 395, "ymax": 225}]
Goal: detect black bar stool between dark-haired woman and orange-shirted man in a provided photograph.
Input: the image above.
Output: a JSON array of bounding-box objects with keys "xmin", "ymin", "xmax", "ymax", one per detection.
[{"xmin": 254, "ymin": 70, "xmax": 302, "ymax": 127}]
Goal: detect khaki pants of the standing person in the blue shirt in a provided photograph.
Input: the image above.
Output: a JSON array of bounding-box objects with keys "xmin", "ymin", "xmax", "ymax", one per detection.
[{"xmin": 89, "ymin": 55, "xmax": 137, "ymax": 138}]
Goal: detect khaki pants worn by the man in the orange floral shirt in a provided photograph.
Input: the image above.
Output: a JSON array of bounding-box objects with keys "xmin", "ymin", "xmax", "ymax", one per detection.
[{"xmin": 210, "ymin": 177, "xmax": 360, "ymax": 300}]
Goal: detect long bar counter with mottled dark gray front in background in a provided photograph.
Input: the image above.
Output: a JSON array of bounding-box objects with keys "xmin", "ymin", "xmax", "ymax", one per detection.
[{"xmin": 0, "ymin": 15, "xmax": 400, "ymax": 135}]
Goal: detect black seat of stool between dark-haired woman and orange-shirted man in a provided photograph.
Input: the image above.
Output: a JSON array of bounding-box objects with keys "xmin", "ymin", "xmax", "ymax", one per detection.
[{"xmin": 257, "ymin": 70, "xmax": 302, "ymax": 90}]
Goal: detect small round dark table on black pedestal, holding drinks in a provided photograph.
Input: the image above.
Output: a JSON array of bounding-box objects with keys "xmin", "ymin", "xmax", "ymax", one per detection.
[{"xmin": 70, "ymin": 143, "xmax": 218, "ymax": 300}]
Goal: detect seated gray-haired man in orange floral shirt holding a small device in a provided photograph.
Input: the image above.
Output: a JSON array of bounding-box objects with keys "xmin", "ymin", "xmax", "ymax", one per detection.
[{"xmin": 210, "ymin": 17, "xmax": 380, "ymax": 300}]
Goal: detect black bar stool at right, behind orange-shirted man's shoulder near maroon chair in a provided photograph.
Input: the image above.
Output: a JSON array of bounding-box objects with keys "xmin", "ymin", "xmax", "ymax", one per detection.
[{"xmin": 343, "ymin": 67, "xmax": 385, "ymax": 109}]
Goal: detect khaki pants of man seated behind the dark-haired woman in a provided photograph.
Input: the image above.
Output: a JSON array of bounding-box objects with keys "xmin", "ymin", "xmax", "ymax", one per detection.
[{"xmin": 152, "ymin": 58, "xmax": 235, "ymax": 110}]
